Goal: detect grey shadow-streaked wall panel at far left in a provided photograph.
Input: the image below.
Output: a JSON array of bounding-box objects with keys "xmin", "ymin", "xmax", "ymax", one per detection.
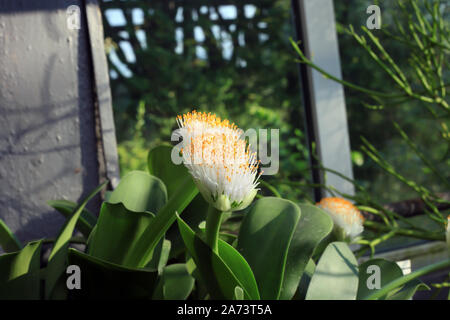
[{"xmin": 0, "ymin": 0, "xmax": 117, "ymax": 245}]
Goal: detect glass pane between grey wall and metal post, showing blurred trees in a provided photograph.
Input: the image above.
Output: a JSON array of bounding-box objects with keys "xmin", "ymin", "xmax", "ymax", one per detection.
[{"xmin": 102, "ymin": 0, "xmax": 310, "ymax": 201}]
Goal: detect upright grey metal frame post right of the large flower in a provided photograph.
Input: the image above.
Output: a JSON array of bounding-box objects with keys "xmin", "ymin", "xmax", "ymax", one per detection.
[{"xmin": 292, "ymin": 0, "xmax": 354, "ymax": 201}]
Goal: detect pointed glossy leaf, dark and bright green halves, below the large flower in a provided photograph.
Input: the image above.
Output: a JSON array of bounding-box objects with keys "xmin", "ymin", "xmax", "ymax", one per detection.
[{"xmin": 178, "ymin": 212, "xmax": 259, "ymax": 300}]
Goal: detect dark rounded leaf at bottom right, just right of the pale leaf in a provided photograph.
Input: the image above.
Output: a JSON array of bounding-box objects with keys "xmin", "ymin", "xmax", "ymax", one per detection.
[{"xmin": 358, "ymin": 259, "xmax": 403, "ymax": 300}]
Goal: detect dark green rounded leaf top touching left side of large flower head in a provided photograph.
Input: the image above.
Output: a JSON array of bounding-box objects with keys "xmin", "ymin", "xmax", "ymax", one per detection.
[{"xmin": 148, "ymin": 144, "xmax": 190, "ymax": 198}]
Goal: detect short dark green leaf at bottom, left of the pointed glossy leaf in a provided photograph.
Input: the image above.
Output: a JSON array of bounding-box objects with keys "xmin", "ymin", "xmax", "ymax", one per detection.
[{"xmin": 153, "ymin": 263, "xmax": 194, "ymax": 300}]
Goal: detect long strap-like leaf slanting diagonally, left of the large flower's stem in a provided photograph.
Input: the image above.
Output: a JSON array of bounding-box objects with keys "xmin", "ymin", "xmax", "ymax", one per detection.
[{"xmin": 125, "ymin": 177, "xmax": 198, "ymax": 267}]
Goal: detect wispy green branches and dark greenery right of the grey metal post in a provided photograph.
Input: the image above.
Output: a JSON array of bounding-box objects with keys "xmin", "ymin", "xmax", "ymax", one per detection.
[{"xmin": 293, "ymin": 0, "xmax": 450, "ymax": 255}]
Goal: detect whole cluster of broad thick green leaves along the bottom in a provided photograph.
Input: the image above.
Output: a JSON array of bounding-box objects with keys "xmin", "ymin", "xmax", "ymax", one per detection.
[{"xmin": 0, "ymin": 147, "xmax": 450, "ymax": 300}]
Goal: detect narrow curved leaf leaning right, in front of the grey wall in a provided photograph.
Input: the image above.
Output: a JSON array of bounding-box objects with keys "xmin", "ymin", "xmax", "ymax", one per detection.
[{"xmin": 45, "ymin": 180, "xmax": 108, "ymax": 298}]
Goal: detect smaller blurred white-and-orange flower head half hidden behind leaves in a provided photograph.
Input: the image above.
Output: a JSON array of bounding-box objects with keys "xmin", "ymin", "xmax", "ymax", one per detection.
[{"xmin": 317, "ymin": 197, "xmax": 364, "ymax": 240}]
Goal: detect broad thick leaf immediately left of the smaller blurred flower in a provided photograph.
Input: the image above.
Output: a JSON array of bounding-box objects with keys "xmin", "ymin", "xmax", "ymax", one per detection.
[{"xmin": 280, "ymin": 204, "xmax": 333, "ymax": 300}]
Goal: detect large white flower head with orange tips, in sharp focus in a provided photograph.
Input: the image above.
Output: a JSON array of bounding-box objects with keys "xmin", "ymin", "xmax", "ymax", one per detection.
[{"xmin": 177, "ymin": 111, "xmax": 259, "ymax": 211}]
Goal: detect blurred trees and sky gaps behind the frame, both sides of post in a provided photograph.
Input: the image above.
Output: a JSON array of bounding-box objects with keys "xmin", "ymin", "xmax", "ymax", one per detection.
[{"xmin": 101, "ymin": 0, "xmax": 450, "ymax": 202}]
